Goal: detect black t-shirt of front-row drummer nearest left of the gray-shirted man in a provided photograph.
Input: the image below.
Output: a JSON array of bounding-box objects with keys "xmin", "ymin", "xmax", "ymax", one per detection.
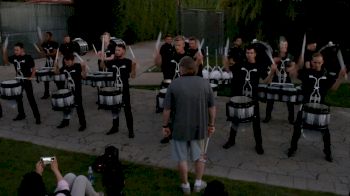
[{"xmin": 107, "ymin": 58, "xmax": 132, "ymax": 86}]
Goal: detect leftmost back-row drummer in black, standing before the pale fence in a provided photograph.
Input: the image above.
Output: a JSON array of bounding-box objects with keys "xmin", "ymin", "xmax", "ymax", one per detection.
[{"xmin": 41, "ymin": 31, "xmax": 59, "ymax": 99}]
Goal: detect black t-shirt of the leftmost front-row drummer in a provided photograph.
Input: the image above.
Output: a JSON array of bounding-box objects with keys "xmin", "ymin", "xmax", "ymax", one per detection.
[{"xmin": 9, "ymin": 54, "xmax": 35, "ymax": 77}]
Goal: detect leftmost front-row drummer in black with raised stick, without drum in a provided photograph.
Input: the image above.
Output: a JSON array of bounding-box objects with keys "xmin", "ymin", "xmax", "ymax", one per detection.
[{"xmin": 3, "ymin": 42, "xmax": 41, "ymax": 124}]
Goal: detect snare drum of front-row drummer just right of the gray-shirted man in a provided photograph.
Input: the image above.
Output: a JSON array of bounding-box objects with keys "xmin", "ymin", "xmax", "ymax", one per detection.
[{"xmin": 226, "ymin": 96, "xmax": 254, "ymax": 123}]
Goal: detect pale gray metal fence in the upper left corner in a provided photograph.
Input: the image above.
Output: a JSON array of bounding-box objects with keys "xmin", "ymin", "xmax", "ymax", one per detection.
[{"xmin": 0, "ymin": 1, "xmax": 74, "ymax": 65}]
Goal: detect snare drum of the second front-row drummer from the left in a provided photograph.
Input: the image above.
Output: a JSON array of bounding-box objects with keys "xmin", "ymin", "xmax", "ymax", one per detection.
[{"xmin": 51, "ymin": 89, "xmax": 74, "ymax": 111}]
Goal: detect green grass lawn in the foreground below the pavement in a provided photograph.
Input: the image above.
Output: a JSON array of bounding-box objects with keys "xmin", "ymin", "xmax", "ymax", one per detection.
[{"xmin": 0, "ymin": 138, "xmax": 334, "ymax": 196}]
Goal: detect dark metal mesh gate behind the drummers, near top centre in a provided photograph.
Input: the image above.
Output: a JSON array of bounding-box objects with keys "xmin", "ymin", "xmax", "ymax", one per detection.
[{"xmin": 181, "ymin": 9, "xmax": 225, "ymax": 58}]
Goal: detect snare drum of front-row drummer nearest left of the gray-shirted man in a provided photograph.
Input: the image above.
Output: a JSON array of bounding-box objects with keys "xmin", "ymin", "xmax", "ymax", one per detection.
[{"xmin": 98, "ymin": 87, "xmax": 123, "ymax": 110}]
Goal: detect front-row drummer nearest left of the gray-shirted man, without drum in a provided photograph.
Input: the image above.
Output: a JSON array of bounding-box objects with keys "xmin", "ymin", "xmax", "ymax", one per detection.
[{"xmin": 102, "ymin": 44, "xmax": 136, "ymax": 138}]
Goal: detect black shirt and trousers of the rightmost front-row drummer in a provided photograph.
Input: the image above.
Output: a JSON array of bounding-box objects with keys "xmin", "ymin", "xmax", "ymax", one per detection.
[{"xmin": 288, "ymin": 68, "xmax": 336, "ymax": 161}]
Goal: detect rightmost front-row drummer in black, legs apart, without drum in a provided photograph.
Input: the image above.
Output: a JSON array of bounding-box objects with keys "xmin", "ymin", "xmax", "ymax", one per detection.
[{"xmin": 287, "ymin": 53, "xmax": 346, "ymax": 162}]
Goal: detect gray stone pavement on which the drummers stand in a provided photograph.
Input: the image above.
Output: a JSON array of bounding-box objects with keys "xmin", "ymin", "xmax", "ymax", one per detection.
[{"xmin": 0, "ymin": 42, "xmax": 350, "ymax": 195}]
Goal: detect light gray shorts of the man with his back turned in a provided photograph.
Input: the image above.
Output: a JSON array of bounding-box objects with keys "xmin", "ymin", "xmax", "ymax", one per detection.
[{"xmin": 171, "ymin": 139, "xmax": 204, "ymax": 161}]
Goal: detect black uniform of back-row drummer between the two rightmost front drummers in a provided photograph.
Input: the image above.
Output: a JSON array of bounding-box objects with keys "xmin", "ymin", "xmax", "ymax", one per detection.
[{"xmin": 263, "ymin": 53, "xmax": 294, "ymax": 124}]
